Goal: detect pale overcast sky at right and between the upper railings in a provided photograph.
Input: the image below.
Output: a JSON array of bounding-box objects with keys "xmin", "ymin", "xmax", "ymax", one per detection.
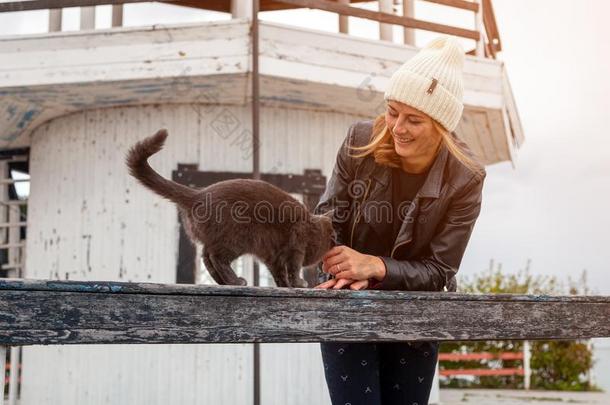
[{"xmin": 0, "ymin": 0, "xmax": 610, "ymax": 294}]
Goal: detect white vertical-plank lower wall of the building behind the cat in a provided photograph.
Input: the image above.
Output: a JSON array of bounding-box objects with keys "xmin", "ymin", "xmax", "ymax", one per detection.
[{"xmin": 21, "ymin": 105, "xmax": 366, "ymax": 405}]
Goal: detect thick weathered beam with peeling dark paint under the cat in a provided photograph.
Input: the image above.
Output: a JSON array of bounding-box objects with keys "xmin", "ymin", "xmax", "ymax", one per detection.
[{"xmin": 0, "ymin": 279, "xmax": 610, "ymax": 345}]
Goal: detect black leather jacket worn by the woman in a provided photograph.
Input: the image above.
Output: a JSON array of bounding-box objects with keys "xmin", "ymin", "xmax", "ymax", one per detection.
[{"xmin": 314, "ymin": 120, "xmax": 486, "ymax": 291}]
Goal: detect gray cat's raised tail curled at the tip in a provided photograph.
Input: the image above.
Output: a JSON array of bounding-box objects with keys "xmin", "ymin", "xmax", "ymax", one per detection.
[{"xmin": 125, "ymin": 129, "xmax": 197, "ymax": 208}]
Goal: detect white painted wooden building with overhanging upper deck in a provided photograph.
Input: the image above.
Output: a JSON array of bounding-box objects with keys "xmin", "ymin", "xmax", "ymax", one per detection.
[{"xmin": 0, "ymin": 1, "xmax": 523, "ymax": 405}]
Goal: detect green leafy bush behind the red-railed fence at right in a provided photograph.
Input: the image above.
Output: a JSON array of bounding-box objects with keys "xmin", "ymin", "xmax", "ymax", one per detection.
[{"xmin": 440, "ymin": 261, "xmax": 596, "ymax": 391}]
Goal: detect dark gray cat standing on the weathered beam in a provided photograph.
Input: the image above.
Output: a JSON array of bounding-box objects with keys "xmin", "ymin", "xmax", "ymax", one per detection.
[{"xmin": 126, "ymin": 129, "xmax": 336, "ymax": 287}]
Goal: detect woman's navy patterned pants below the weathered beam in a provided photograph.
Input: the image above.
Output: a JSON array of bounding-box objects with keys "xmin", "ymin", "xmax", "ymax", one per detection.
[{"xmin": 320, "ymin": 342, "xmax": 438, "ymax": 405}]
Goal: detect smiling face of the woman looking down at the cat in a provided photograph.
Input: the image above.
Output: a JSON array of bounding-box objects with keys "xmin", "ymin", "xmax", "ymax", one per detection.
[{"xmin": 385, "ymin": 100, "xmax": 442, "ymax": 172}]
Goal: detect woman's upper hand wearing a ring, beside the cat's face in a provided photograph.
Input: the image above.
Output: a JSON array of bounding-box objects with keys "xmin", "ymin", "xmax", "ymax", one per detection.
[{"xmin": 322, "ymin": 245, "xmax": 385, "ymax": 280}]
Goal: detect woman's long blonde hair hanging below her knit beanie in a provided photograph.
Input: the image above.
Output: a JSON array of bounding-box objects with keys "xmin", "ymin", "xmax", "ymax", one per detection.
[{"xmin": 350, "ymin": 113, "xmax": 483, "ymax": 176}]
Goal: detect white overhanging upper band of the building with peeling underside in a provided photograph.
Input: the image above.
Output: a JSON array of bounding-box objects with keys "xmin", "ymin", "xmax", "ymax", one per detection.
[{"xmin": 0, "ymin": 19, "xmax": 522, "ymax": 164}]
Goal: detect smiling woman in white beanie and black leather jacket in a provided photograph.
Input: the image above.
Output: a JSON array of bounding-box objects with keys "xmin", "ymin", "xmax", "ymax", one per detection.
[{"xmin": 315, "ymin": 36, "xmax": 486, "ymax": 405}]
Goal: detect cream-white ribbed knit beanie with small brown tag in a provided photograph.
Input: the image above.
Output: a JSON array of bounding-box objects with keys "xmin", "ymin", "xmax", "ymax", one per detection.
[{"xmin": 384, "ymin": 35, "xmax": 464, "ymax": 131}]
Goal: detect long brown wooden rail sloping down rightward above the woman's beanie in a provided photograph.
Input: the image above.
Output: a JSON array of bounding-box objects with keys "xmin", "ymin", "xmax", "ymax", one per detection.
[{"xmin": 277, "ymin": 0, "xmax": 480, "ymax": 41}]
